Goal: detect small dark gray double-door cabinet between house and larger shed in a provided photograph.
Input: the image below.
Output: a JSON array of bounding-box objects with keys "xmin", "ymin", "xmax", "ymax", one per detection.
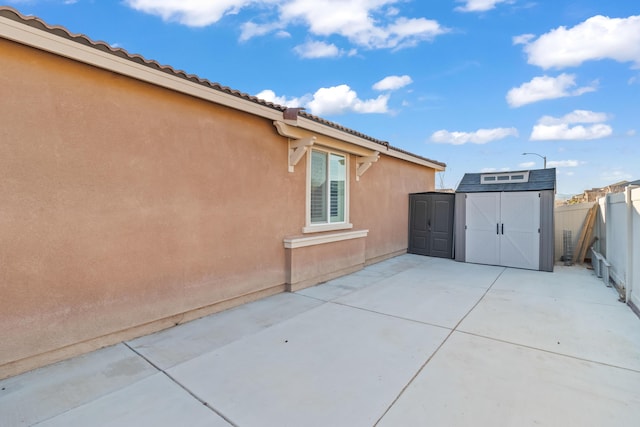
[{"xmin": 407, "ymin": 193, "xmax": 455, "ymax": 258}]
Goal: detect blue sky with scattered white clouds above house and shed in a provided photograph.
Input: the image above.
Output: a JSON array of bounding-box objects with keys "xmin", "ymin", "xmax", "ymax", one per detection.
[{"xmin": 4, "ymin": 0, "xmax": 640, "ymax": 196}]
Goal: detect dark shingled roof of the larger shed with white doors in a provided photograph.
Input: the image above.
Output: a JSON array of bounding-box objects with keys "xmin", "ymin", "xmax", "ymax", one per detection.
[{"xmin": 456, "ymin": 168, "xmax": 556, "ymax": 193}]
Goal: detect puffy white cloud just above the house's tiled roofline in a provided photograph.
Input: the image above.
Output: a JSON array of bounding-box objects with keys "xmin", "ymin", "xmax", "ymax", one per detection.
[{"xmin": 256, "ymin": 84, "xmax": 389, "ymax": 116}]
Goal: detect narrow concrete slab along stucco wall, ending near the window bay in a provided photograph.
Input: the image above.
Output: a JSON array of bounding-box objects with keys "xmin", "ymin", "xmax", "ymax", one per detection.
[{"xmin": 128, "ymin": 293, "xmax": 322, "ymax": 369}]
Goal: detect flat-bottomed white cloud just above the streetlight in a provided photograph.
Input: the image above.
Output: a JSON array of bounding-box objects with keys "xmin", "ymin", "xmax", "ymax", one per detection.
[{"xmin": 529, "ymin": 110, "xmax": 613, "ymax": 141}]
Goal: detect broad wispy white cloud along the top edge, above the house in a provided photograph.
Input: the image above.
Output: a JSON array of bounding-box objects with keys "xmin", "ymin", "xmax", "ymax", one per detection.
[{"xmin": 125, "ymin": 0, "xmax": 450, "ymax": 49}]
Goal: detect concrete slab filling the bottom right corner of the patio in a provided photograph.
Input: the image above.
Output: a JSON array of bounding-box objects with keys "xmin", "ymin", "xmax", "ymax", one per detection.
[{"xmin": 378, "ymin": 332, "xmax": 640, "ymax": 427}]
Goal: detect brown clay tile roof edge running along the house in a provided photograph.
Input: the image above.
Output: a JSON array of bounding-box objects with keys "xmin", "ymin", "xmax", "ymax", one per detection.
[{"xmin": 0, "ymin": 6, "xmax": 446, "ymax": 167}]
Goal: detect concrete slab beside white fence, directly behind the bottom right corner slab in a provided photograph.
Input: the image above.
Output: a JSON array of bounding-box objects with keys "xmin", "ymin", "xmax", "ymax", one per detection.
[{"xmin": 459, "ymin": 289, "xmax": 640, "ymax": 371}]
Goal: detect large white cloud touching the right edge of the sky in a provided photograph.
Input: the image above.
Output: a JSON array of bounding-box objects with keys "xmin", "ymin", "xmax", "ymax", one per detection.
[{"xmin": 524, "ymin": 15, "xmax": 640, "ymax": 69}]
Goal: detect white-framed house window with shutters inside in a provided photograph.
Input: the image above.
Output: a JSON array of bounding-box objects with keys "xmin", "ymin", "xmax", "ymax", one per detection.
[{"xmin": 304, "ymin": 149, "xmax": 351, "ymax": 232}]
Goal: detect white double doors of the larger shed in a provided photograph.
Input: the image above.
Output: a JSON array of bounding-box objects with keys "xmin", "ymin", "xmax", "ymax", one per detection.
[{"xmin": 465, "ymin": 191, "xmax": 540, "ymax": 270}]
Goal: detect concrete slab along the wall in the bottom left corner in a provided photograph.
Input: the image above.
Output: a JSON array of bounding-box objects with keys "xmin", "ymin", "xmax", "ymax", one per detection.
[{"xmin": 0, "ymin": 344, "xmax": 157, "ymax": 426}]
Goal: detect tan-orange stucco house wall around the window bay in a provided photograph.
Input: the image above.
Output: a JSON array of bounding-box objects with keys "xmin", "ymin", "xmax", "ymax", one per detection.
[{"xmin": 0, "ymin": 40, "xmax": 433, "ymax": 378}]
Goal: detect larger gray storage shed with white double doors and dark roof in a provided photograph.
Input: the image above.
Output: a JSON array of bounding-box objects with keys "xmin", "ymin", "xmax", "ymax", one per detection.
[{"xmin": 455, "ymin": 168, "xmax": 556, "ymax": 271}]
